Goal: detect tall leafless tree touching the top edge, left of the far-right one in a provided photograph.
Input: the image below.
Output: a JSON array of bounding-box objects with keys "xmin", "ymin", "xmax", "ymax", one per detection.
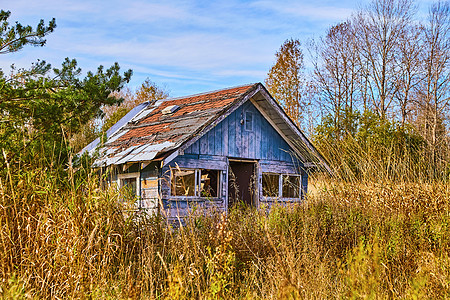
[{"xmin": 352, "ymin": 0, "xmax": 414, "ymax": 119}]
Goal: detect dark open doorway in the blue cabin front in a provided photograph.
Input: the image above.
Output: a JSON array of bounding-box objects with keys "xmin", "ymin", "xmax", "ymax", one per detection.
[{"xmin": 228, "ymin": 161, "xmax": 257, "ymax": 207}]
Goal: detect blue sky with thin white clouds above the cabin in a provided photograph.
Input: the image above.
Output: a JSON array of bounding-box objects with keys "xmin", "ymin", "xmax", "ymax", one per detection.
[{"xmin": 0, "ymin": 0, "xmax": 432, "ymax": 97}]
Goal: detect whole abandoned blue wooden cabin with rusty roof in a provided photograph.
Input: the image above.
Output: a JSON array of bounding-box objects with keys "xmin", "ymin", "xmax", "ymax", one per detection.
[{"xmin": 83, "ymin": 83, "xmax": 327, "ymax": 217}]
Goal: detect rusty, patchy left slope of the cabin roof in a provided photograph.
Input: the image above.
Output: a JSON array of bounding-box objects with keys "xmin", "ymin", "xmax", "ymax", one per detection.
[{"xmin": 82, "ymin": 84, "xmax": 258, "ymax": 167}]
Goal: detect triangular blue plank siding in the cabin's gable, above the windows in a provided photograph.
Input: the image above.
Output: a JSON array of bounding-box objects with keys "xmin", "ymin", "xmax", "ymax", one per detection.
[{"xmin": 184, "ymin": 102, "xmax": 293, "ymax": 163}]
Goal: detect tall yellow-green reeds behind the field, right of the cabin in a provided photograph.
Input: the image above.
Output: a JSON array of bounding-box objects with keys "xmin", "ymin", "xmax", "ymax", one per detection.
[{"xmin": 316, "ymin": 125, "xmax": 450, "ymax": 183}]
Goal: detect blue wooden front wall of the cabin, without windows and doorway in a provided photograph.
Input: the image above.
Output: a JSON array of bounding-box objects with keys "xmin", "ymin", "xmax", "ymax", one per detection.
[{"xmin": 160, "ymin": 101, "xmax": 308, "ymax": 217}]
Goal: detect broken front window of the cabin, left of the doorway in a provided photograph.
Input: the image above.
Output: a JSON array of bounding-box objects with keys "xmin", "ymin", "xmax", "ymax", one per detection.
[{"xmin": 171, "ymin": 169, "xmax": 220, "ymax": 198}]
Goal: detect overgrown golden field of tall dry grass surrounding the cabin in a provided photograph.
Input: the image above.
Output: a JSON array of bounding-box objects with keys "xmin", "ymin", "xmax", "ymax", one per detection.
[{"xmin": 0, "ymin": 165, "xmax": 450, "ymax": 299}]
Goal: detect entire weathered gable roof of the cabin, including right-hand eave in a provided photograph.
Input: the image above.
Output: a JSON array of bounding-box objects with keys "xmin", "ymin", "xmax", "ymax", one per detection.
[{"xmin": 81, "ymin": 83, "xmax": 329, "ymax": 169}]
